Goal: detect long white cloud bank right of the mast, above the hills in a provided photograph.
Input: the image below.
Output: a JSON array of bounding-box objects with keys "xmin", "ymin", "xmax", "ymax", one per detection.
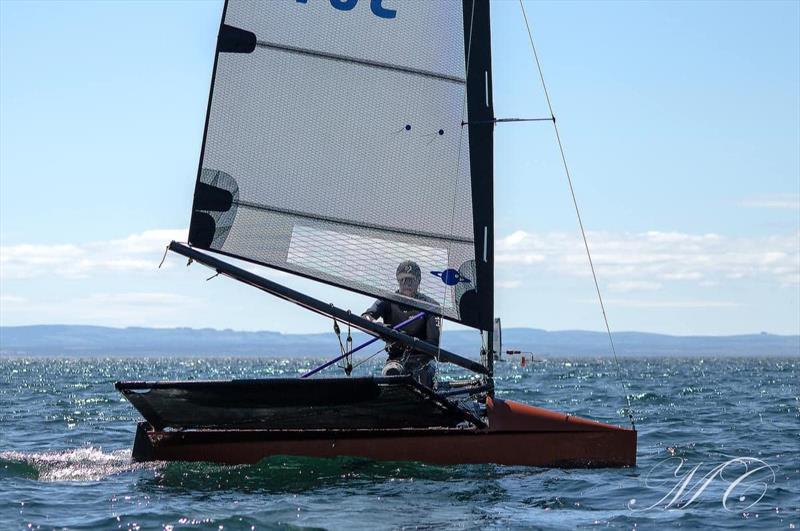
[{"xmin": 496, "ymin": 231, "xmax": 800, "ymax": 291}]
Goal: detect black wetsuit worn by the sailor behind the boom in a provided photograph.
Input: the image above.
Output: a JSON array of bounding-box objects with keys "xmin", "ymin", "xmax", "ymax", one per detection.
[{"xmin": 364, "ymin": 293, "xmax": 440, "ymax": 362}]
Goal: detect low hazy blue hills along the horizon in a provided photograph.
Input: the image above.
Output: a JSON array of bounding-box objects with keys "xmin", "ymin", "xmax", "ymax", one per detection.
[{"xmin": 0, "ymin": 325, "xmax": 800, "ymax": 358}]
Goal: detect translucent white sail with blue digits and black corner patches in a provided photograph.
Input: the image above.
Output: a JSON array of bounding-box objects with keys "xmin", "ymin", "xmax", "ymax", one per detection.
[{"xmin": 189, "ymin": 0, "xmax": 493, "ymax": 330}]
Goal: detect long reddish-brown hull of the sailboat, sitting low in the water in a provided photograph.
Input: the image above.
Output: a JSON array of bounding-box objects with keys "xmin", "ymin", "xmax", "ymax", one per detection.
[{"xmin": 128, "ymin": 400, "xmax": 636, "ymax": 467}]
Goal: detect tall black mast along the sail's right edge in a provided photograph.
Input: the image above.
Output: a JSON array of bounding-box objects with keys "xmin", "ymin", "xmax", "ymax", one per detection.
[{"xmin": 462, "ymin": 0, "xmax": 494, "ymax": 374}]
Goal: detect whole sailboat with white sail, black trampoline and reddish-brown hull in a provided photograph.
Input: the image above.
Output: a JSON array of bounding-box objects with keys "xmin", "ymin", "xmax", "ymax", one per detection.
[{"xmin": 116, "ymin": 0, "xmax": 636, "ymax": 467}]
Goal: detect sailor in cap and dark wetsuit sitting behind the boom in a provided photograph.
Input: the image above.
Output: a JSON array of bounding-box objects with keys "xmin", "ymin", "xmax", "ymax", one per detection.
[{"xmin": 362, "ymin": 260, "xmax": 440, "ymax": 387}]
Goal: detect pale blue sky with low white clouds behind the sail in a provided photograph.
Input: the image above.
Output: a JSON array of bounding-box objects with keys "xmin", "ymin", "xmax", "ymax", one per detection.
[{"xmin": 0, "ymin": 0, "xmax": 800, "ymax": 334}]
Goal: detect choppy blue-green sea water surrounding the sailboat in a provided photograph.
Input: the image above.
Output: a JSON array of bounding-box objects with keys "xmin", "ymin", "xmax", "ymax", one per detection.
[{"xmin": 0, "ymin": 357, "xmax": 800, "ymax": 530}]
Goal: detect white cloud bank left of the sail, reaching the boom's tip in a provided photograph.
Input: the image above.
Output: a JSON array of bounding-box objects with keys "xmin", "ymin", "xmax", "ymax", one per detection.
[{"xmin": 0, "ymin": 229, "xmax": 187, "ymax": 279}]
